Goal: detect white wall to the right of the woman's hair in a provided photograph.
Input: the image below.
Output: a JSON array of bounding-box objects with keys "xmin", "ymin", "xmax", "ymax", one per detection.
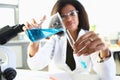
[{"xmin": 79, "ymin": 0, "xmax": 120, "ymax": 34}]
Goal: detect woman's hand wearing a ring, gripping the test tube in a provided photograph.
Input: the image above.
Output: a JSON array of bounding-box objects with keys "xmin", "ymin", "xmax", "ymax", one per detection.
[{"xmin": 73, "ymin": 31, "xmax": 109, "ymax": 57}]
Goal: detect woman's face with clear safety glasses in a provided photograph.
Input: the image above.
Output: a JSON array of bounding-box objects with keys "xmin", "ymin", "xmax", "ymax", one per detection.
[{"xmin": 61, "ymin": 4, "xmax": 79, "ymax": 31}]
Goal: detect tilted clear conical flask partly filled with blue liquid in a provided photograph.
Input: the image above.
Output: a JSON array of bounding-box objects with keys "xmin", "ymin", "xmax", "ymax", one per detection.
[{"xmin": 26, "ymin": 13, "xmax": 64, "ymax": 42}]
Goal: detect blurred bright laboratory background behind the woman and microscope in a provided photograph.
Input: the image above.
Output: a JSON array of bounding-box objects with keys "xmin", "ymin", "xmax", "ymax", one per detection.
[{"xmin": 0, "ymin": 0, "xmax": 120, "ymax": 76}]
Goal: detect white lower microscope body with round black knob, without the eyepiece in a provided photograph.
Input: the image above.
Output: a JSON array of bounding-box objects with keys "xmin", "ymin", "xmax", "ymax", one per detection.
[{"xmin": 0, "ymin": 46, "xmax": 17, "ymax": 80}]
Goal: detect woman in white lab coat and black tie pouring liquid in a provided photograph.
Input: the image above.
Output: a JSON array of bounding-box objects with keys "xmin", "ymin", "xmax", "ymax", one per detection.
[{"xmin": 24, "ymin": 0, "xmax": 116, "ymax": 80}]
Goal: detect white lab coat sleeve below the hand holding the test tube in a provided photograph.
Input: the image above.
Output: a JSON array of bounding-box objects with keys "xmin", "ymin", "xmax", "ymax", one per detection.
[{"xmin": 91, "ymin": 52, "xmax": 116, "ymax": 80}]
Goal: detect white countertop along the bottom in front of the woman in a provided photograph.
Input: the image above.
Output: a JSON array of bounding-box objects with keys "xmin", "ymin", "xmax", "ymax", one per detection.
[{"xmin": 14, "ymin": 69, "xmax": 120, "ymax": 80}]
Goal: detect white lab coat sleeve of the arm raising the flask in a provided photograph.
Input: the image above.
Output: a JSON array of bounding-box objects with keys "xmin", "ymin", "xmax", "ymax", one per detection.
[{"xmin": 27, "ymin": 40, "xmax": 54, "ymax": 70}]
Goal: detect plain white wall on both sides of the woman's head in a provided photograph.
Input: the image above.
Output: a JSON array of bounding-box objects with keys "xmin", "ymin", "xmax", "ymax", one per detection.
[{"xmin": 19, "ymin": 0, "xmax": 120, "ymax": 34}]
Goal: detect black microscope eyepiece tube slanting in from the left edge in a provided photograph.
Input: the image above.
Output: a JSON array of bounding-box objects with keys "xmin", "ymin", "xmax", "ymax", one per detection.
[{"xmin": 0, "ymin": 24, "xmax": 25, "ymax": 45}]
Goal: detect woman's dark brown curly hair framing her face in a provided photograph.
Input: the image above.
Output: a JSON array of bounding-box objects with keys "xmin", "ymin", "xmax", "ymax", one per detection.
[{"xmin": 51, "ymin": 0, "xmax": 89, "ymax": 32}]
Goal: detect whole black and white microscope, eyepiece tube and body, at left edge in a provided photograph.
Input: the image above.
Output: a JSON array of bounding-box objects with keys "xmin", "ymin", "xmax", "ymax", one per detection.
[{"xmin": 0, "ymin": 24, "xmax": 24, "ymax": 80}]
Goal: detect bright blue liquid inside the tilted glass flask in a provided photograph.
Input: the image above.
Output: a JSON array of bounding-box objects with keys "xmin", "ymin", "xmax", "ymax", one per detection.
[{"xmin": 26, "ymin": 28, "xmax": 63, "ymax": 42}]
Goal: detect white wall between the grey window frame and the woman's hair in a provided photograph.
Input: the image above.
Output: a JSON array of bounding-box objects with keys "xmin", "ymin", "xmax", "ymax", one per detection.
[{"xmin": 19, "ymin": 0, "xmax": 56, "ymax": 23}]
